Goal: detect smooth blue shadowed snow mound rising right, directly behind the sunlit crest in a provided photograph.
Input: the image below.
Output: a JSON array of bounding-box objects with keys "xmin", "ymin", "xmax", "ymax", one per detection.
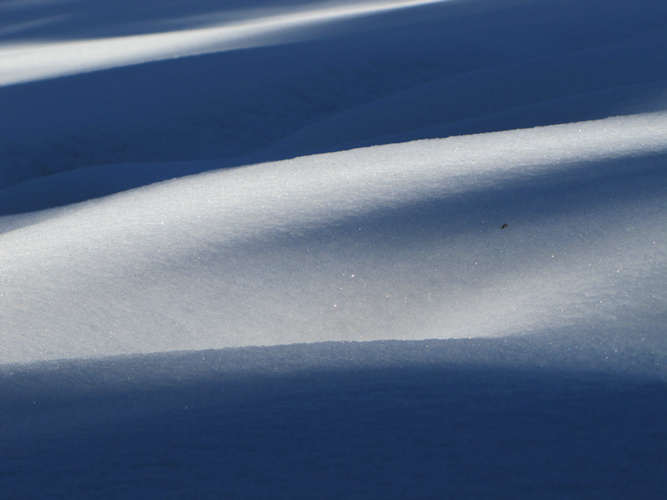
[{"xmin": 263, "ymin": 41, "xmax": 667, "ymax": 158}]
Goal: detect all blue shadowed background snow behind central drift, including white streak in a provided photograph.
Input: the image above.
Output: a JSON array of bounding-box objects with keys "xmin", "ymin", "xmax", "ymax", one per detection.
[{"xmin": 0, "ymin": 0, "xmax": 667, "ymax": 195}]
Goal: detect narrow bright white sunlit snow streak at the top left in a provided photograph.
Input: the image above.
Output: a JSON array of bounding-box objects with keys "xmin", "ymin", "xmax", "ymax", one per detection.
[{"xmin": 0, "ymin": 0, "xmax": 448, "ymax": 86}]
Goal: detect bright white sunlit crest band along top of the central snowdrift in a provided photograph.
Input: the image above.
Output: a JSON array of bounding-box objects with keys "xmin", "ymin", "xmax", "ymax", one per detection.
[{"xmin": 5, "ymin": 112, "xmax": 667, "ymax": 249}]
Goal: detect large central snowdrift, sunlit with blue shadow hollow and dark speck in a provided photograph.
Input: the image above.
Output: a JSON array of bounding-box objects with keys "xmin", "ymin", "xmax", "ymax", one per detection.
[{"xmin": 0, "ymin": 113, "xmax": 667, "ymax": 363}]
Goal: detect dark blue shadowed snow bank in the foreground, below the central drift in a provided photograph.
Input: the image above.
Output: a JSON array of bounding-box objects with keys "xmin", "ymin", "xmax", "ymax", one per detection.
[{"xmin": 0, "ymin": 338, "xmax": 667, "ymax": 499}]
